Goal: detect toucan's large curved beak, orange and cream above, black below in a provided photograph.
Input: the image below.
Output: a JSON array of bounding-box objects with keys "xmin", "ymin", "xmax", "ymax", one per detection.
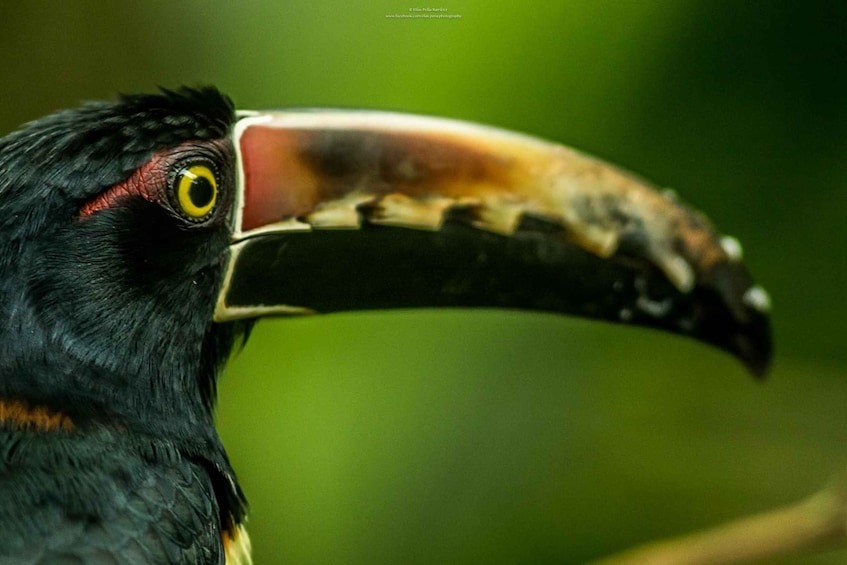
[{"xmin": 215, "ymin": 110, "xmax": 771, "ymax": 375}]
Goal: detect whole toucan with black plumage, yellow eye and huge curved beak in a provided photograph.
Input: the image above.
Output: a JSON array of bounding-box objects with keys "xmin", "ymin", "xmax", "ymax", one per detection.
[{"xmin": 0, "ymin": 86, "xmax": 772, "ymax": 565}]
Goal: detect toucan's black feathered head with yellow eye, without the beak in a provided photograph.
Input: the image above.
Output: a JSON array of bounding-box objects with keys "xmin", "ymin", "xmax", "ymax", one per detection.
[{"xmin": 0, "ymin": 89, "xmax": 242, "ymax": 429}]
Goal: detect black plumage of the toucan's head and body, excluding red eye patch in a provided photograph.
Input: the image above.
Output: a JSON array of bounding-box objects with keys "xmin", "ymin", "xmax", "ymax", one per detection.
[{"xmin": 0, "ymin": 88, "xmax": 246, "ymax": 563}]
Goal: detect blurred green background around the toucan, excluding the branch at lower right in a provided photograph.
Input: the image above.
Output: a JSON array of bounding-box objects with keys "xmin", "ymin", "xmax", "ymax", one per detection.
[{"xmin": 0, "ymin": 0, "xmax": 847, "ymax": 564}]
